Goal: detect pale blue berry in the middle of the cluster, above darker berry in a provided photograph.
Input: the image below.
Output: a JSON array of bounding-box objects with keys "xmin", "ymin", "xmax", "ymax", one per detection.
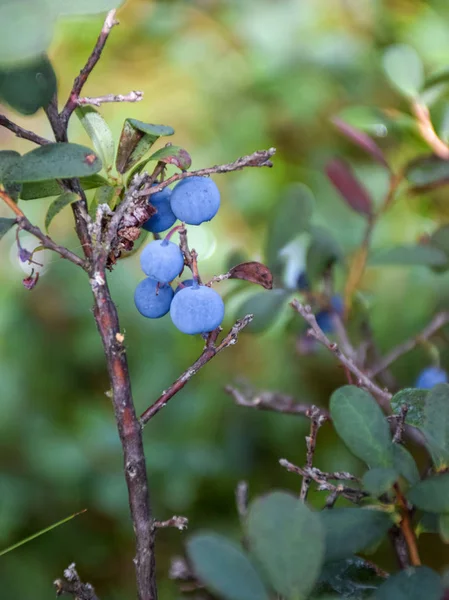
[{"xmin": 140, "ymin": 240, "xmax": 184, "ymax": 283}]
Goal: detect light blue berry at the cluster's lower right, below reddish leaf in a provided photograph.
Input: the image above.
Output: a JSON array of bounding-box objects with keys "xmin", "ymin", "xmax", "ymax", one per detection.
[{"xmin": 170, "ymin": 283, "xmax": 224, "ymax": 335}]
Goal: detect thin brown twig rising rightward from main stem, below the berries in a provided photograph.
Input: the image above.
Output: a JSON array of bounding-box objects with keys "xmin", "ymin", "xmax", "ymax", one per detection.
[{"xmin": 139, "ymin": 315, "xmax": 253, "ymax": 427}]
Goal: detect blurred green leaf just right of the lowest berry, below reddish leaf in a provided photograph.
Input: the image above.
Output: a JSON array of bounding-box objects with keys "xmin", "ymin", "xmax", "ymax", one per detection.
[{"xmin": 238, "ymin": 289, "xmax": 288, "ymax": 333}]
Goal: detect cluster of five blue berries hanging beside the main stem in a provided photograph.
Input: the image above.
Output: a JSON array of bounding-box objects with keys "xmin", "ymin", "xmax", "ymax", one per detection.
[{"xmin": 134, "ymin": 176, "xmax": 224, "ymax": 335}]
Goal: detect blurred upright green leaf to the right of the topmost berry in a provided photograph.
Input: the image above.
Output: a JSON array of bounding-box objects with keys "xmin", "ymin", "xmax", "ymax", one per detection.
[{"xmin": 266, "ymin": 183, "xmax": 315, "ymax": 272}]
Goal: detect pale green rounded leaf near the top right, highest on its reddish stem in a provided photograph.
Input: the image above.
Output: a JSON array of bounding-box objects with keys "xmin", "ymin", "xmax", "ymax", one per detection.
[{"xmin": 382, "ymin": 44, "xmax": 424, "ymax": 97}]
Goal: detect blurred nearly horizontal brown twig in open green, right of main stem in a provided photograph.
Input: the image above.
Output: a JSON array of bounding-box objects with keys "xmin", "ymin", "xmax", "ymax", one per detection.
[{"xmin": 225, "ymin": 385, "xmax": 330, "ymax": 420}]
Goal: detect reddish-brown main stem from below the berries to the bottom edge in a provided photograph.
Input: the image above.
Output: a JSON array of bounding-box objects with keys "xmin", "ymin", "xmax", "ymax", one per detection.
[{"xmin": 90, "ymin": 268, "xmax": 157, "ymax": 600}]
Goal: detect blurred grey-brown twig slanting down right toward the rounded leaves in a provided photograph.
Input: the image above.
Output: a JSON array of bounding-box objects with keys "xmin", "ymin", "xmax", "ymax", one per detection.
[{"xmin": 291, "ymin": 300, "xmax": 392, "ymax": 409}]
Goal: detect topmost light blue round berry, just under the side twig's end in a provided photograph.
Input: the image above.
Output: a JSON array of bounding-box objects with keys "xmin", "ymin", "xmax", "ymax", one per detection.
[{"xmin": 170, "ymin": 176, "xmax": 220, "ymax": 225}]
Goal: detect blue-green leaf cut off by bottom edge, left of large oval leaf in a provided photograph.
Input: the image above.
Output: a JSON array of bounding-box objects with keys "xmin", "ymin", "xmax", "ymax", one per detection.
[{"xmin": 187, "ymin": 533, "xmax": 269, "ymax": 600}]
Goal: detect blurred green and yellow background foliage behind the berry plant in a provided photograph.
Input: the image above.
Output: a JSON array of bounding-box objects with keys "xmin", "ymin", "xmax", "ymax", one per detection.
[{"xmin": 0, "ymin": 0, "xmax": 449, "ymax": 600}]
